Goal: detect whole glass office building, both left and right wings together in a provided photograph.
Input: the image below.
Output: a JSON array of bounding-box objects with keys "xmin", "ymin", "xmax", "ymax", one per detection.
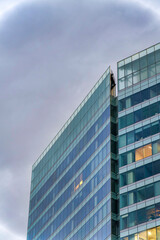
[{"xmin": 27, "ymin": 43, "xmax": 160, "ymax": 240}]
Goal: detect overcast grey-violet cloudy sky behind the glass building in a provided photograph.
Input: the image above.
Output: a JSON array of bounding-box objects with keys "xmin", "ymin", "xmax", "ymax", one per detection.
[{"xmin": 0, "ymin": 0, "xmax": 160, "ymax": 240}]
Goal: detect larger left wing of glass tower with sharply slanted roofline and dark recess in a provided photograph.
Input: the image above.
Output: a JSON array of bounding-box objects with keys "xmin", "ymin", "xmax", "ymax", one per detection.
[{"xmin": 27, "ymin": 68, "xmax": 119, "ymax": 240}]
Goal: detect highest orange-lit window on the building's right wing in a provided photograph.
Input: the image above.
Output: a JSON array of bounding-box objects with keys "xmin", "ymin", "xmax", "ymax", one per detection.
[{"xmin": 135, "ymin": 144, "xmax": 152, "ymax": 161}]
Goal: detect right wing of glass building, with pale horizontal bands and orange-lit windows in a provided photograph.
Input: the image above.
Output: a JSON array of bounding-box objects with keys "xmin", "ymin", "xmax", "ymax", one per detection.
[{"xmin": 118, "ymin": 44, "xmax": 160, "ymax": 240}]
